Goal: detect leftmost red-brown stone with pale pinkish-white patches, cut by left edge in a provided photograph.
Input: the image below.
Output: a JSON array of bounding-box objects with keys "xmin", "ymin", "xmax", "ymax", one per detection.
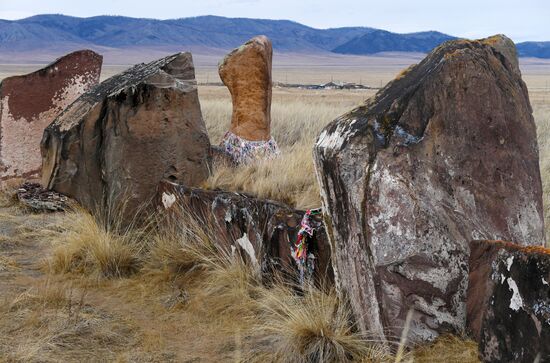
[{"xmin": 0, "ymin": 50, "xmax": 103, "ymax": 180}]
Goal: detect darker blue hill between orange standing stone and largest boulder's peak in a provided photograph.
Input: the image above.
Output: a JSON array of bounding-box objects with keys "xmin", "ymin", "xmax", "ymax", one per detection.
[{"xmin": 333, "ymin": 30, "xmax": 456, "ymax": 54}]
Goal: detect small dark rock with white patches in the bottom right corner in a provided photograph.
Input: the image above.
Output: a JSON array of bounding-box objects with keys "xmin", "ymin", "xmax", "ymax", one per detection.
[{"xmin": 467, "ymin": 241, "xmax": 550, "ymax": 363}]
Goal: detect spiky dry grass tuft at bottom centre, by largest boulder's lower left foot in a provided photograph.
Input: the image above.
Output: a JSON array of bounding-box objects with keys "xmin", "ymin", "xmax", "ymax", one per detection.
[{"xmin": 251, "ymin": 284, "xmax": 393, "ymax": 363}]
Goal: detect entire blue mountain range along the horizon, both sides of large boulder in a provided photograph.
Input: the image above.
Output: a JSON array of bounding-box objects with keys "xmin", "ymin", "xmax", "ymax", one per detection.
[{"xmin": 0, "ymin": 15, "xmax": 550, "ymax": 58}]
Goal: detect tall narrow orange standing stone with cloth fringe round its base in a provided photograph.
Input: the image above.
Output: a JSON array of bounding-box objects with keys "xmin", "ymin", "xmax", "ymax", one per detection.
[{"xmin": 219, "ymin": 35, "xmax": 279, "ymax": 162}]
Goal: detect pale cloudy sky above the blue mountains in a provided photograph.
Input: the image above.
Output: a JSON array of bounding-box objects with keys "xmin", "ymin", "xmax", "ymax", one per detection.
[{"xmin": 0, "ymin": 0, "xmax": 550, "ymax": 42}]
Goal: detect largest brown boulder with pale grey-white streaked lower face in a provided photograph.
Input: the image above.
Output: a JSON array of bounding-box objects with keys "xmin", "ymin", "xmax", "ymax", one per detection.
[{"xmin": 314, "ymin": 36, "xmax": 544, "ymax": 342}]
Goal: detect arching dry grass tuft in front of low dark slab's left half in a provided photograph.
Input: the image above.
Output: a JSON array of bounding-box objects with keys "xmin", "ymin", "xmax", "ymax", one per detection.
[{"xmin": 145, "ymin": 214, "xmax": 261, "ymax": 324}]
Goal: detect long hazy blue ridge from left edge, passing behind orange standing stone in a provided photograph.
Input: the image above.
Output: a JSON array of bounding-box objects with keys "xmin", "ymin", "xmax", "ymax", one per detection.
[{"xmin": 0, "ymin": 15, "xmax": 372, "ymax": 52}]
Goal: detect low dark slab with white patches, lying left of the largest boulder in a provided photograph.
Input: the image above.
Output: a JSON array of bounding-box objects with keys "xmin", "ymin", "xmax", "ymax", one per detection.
[{"xmin": 156, "ymin": 181, "xmax": 333, "ymax": 284}]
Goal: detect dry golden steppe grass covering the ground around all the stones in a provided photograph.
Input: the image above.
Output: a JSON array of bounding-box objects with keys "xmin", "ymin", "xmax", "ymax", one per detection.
[{"xmin": 0, "ymin": 60, "xmax": 550, "ymax": 363}]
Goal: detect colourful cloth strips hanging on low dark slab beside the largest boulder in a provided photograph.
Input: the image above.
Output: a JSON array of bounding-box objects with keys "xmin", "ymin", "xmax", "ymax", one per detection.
[{"xmin": 290, "ymin": 208, "xmax": 322, "ymax": 285}]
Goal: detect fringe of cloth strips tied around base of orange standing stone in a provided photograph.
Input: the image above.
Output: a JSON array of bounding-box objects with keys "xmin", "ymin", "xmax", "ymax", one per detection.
[{"xmin": 220, "ymin": 131, "xmax": 281, "ymax": 164}]
